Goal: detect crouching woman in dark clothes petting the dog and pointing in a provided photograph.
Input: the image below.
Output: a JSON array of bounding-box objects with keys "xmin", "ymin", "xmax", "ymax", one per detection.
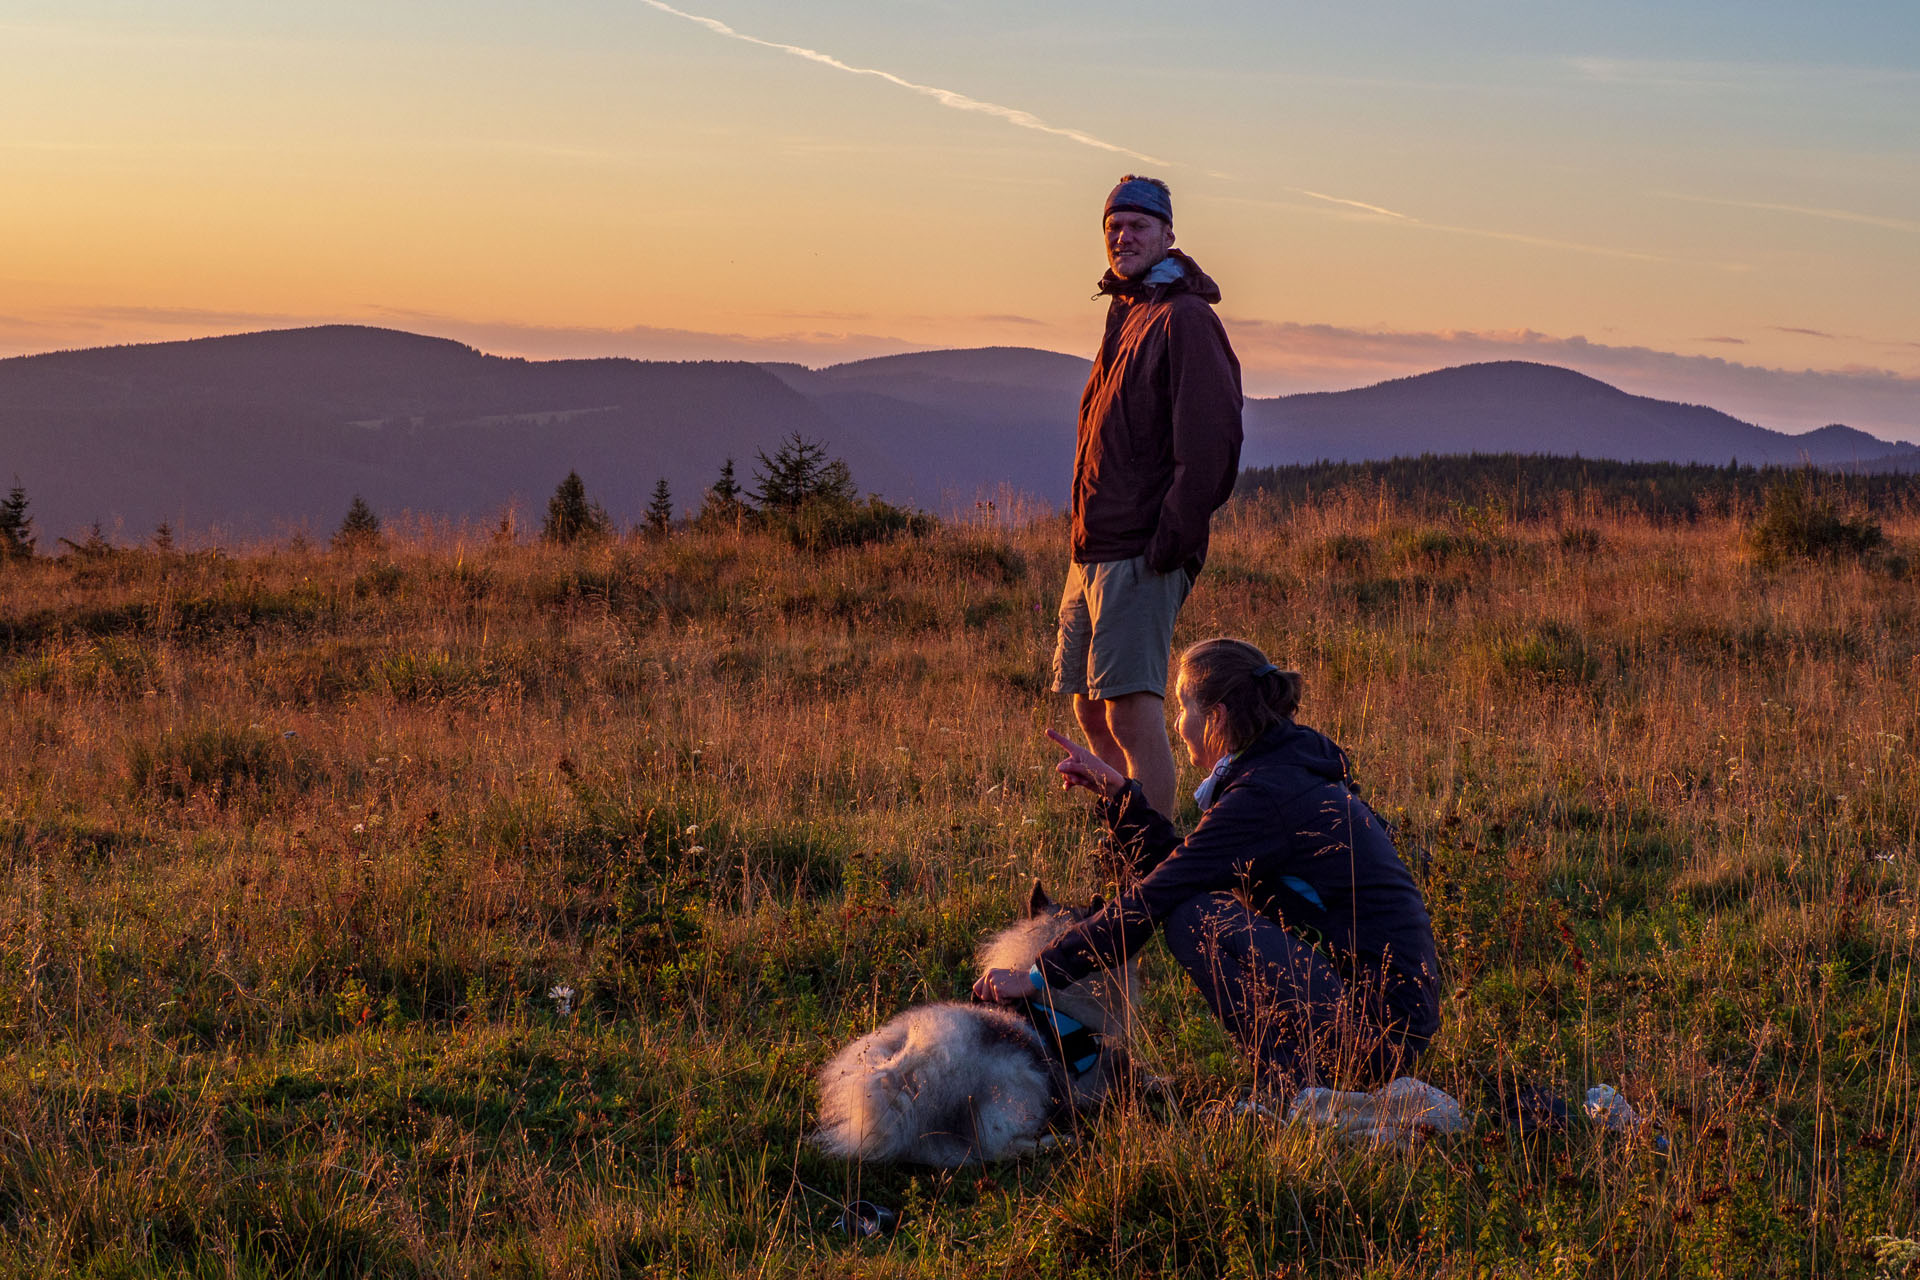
[{"xmin": 973, "ymin": 639, "xmax": 1440, "ymax": 1092}]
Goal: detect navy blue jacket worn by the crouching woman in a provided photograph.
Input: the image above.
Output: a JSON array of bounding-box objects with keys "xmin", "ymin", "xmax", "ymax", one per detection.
[{"xmin": 1039, "ymin": 722, "xmax": 1440, "ymax": 1038}]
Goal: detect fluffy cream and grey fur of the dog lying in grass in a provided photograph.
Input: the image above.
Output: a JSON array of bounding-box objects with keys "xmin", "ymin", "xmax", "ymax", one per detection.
[{"xmin": 814, "ymin": 881, "xmax": 1135, "ymax": 1167}]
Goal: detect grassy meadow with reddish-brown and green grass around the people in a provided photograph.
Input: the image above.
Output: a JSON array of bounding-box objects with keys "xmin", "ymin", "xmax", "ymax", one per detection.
[{"xmin": 0, "ymin": 491, "xmax": 1920, "ymax": 1278}]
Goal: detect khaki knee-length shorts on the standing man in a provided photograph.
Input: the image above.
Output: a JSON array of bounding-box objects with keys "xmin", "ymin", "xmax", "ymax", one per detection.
[{"xmin": 1054, "ymin": 557, "xmax": 1192, "ymax": 699}]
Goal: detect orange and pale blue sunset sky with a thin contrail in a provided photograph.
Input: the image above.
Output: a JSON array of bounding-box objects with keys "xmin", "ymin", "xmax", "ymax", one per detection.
[{"xmin": 0, "ymin": 0, "xmax": 1920, "ymax": 439}]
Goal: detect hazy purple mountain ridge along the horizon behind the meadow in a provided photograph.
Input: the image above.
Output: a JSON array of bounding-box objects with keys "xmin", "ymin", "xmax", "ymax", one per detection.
[{"xmin": 0, "ymin": 326, "xmax": 1920, "ymax": 545}]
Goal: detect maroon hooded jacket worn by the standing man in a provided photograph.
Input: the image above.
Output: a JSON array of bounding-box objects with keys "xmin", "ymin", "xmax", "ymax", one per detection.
[{"xmin": 1073, "ymin": 249, "xmax": 1240, "ymax": 574}]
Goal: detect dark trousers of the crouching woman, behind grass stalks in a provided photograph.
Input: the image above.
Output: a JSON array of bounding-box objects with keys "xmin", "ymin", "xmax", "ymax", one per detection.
[{"xmin": 1162, "ymin": 892, "xmax": 1425, "ymax": 1094}]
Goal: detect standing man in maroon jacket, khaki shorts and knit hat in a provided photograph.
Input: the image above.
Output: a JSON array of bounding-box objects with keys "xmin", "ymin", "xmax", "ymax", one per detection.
[{"xmin": 1054, "ymin": 175, "xmax": 1240, "ymax": 816}]
